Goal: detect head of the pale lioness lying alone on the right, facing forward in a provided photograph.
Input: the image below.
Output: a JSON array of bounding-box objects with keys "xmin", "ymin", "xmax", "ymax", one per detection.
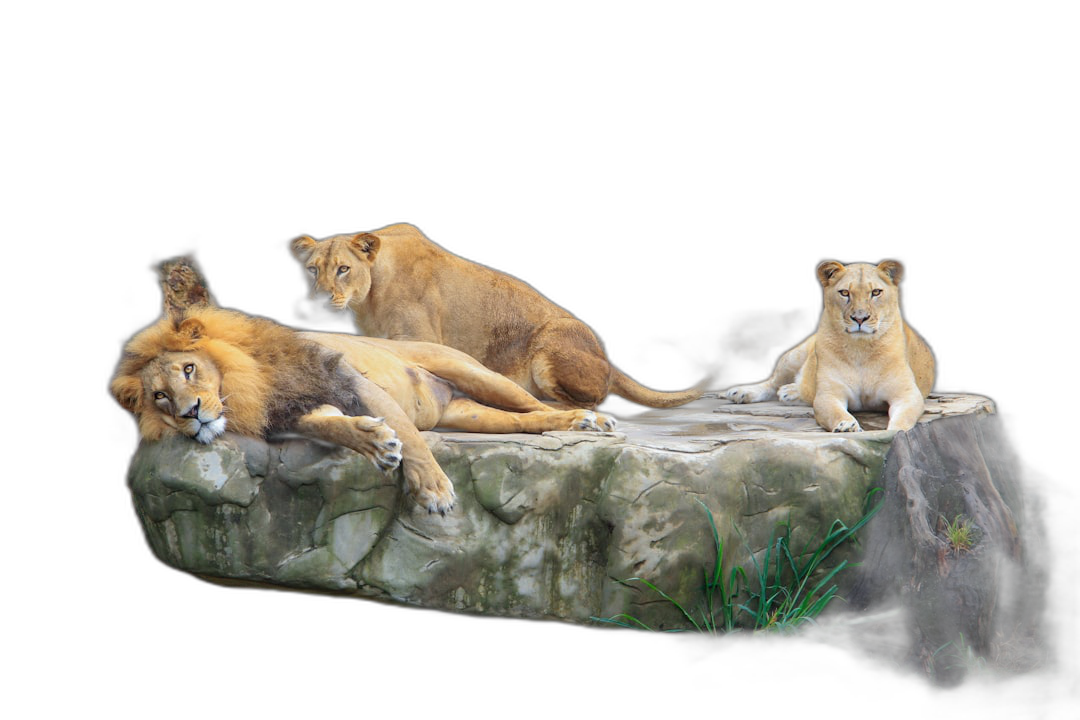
[{"xmin": 818, "ymin": 260, "xmax": 904, "ymax": 338}]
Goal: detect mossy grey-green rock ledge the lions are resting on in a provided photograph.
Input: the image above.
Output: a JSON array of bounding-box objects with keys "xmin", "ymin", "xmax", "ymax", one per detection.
[{"xmin": 127, "ymin": 395, "xmax": 994, "ymax": 627}]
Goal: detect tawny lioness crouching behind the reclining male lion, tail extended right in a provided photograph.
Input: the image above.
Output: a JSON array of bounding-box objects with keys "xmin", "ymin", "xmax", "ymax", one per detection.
[{"xmin": 288, "ymin": 225, "xmax": 713, "ymax": 409}]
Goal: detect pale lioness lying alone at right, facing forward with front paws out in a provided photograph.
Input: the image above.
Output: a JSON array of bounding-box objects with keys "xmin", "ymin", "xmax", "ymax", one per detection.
[{"xmin": 720, "ymin": 260, "xmax": 935, "ymax": 433}]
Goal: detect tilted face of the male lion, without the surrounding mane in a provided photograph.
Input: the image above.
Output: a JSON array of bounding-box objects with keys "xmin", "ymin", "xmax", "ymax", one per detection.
[{"xmin": 136, "ymin": 352, "xmax": 226, "ymax": 443}]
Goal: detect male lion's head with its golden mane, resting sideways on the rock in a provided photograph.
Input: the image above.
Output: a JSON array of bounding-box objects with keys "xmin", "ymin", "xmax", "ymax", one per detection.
[{"xmin": 109, "ymin": 310, "xmax": 268, "ymax": 443}]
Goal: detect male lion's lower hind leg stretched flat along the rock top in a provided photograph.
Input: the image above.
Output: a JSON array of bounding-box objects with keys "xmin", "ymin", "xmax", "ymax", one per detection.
[{"xmin": 436, "ymin": 395, "xmax": 616, "ymax": 433}]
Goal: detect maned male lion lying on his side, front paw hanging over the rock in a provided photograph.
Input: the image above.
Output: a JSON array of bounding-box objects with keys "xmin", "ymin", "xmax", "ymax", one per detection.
[{"xmin": 109, "ymin": 259, "xmax": 615, "ymax": 514}]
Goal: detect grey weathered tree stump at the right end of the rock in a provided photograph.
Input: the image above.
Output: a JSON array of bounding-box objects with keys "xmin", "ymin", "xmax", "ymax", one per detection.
[{"xmin": 846, "ymin": 415, "xmax": 1044, "ymax": 688}]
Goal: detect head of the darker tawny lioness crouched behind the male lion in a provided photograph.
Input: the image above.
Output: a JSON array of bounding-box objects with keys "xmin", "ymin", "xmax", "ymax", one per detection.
[{"xmin": 288, "ymin": 232, "xmax": 379, "ymax": 312}]
